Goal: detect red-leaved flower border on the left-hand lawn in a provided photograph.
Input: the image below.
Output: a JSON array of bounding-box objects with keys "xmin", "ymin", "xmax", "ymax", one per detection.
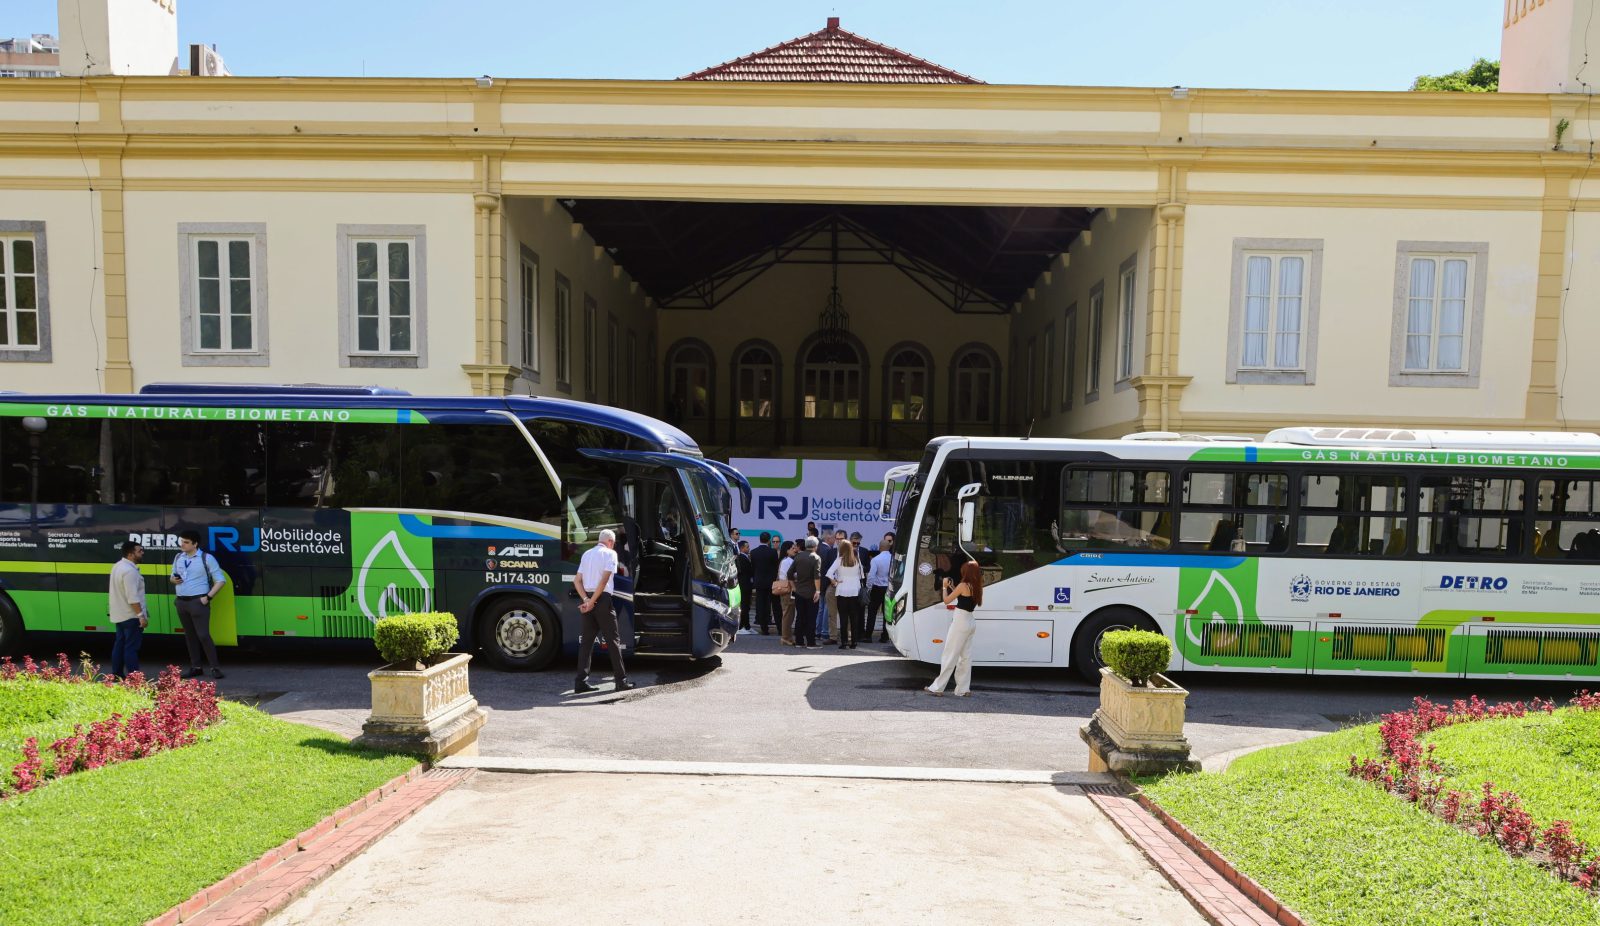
[{"xmin": 0, "ymin": 654, "xmax": 222, "ymax": 798}]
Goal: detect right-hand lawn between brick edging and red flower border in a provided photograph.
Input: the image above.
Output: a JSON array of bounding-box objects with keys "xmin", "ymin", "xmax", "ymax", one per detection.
[{"xmin": 1146, "ymin": 721, "xmax": 1600, "ymax": 926}]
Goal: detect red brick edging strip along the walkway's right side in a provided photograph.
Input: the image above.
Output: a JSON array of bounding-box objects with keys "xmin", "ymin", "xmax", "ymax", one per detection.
[{"xmin": 1083, "ymin": 787, "xmax": 1307, "ymax": 926}]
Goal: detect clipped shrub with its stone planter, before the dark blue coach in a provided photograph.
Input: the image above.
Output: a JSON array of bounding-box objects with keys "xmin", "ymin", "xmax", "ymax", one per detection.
[{"xmin": 355, "ymin": 614, "xmax": 488, "ymax": 758}]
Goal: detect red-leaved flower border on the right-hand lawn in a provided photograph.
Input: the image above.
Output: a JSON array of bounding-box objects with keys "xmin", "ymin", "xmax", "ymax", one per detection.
[{"xmin": 1349, "ymin": 691, "xmax": 1600, "ymax": 894}]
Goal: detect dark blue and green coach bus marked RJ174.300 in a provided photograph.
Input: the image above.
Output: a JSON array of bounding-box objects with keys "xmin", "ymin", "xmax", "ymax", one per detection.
[{"xmin": 0, "ymin": 384, "xmax": 749, "ymax": 669}]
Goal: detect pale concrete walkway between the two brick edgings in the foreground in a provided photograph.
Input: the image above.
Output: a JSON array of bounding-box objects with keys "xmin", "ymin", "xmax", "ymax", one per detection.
[{"xmin": 272, "ymin": 772, "xmax": 1205, "ymax": 926}]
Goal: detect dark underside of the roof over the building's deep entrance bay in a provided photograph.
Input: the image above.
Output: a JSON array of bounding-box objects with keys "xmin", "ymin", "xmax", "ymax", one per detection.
[{"xmin": 562, "ymin": 200, "xmax": 1094, "ymax": 312}]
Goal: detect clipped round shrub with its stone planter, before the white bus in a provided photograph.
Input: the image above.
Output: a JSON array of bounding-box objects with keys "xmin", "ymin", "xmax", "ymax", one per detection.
[{"xmin": 1078, "ymin": 630, "xmax": 1200, "ymax": 774}]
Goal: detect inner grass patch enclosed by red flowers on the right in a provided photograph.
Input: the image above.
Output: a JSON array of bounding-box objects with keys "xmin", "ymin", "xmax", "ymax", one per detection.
[{"xmin": 1422, "ymin": 710, "xmax": 1600, "ymax": 848}]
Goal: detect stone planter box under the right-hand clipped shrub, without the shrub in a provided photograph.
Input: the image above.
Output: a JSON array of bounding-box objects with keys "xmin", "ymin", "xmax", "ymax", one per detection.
[{"xmin": 1078, "ymin": 669, "xmax": 1200, "ymax": 774}]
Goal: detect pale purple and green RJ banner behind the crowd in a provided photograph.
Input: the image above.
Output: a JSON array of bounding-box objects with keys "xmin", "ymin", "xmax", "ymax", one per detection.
[{"xmin": 730, "ymin": 457, "xmax": 904, "ymax": 542}]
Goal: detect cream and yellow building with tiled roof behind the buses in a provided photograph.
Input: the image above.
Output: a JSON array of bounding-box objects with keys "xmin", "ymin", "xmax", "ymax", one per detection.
[{"xmin": 0, "ymin": 0, "xmax": 1600, "ymax": 459}]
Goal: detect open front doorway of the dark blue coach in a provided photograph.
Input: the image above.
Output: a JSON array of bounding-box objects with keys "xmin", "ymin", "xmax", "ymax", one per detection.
[{"xmin": 622, "ymin": 470, "xmax": 693, "ymax": 653}]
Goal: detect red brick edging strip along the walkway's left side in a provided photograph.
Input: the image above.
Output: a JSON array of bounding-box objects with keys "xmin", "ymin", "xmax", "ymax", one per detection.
[{"xmin": 144, "ymin": 764, "xmax": 472, "ymax": 926}]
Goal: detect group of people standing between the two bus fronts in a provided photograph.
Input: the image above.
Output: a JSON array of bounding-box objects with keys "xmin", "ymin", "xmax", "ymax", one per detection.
[{"xmin": 738, "ymin": 523, "xmax": 894, "ymax": 649}]
